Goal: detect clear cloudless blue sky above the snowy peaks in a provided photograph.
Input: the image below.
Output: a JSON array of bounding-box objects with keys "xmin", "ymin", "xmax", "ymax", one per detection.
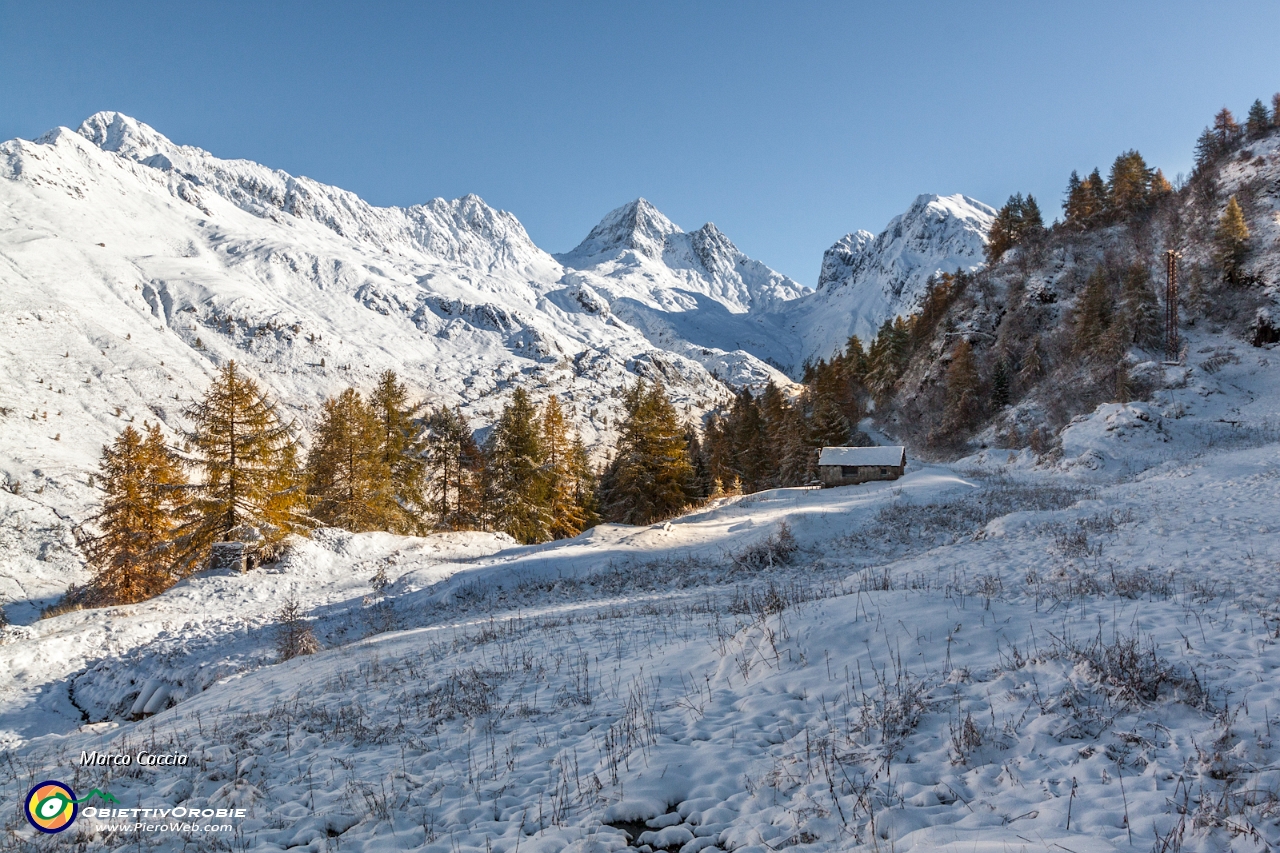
[{"xmin": 0, "ymin": 0, "xmax": 1280, "ymax": 286}]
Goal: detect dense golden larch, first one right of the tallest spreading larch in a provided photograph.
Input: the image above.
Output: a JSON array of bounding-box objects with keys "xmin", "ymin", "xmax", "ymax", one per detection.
[{"xmin": 307, "ymin": 388, "xmax": 399, "ymax": 533}]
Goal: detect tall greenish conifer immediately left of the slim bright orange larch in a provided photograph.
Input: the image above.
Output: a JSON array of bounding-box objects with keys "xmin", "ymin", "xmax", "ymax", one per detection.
[{"xmin": 485, "ymin": 388, "xmax": 552, "ymax": 544}]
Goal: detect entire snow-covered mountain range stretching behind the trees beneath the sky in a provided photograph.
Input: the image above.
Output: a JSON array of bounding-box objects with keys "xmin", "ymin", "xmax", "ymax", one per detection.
[{"xmin": 0, "ymin": 113, "xmax": 995, "ymax": 594}]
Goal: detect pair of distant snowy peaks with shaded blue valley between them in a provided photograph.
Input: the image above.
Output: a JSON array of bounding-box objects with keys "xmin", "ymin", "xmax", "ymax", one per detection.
[{"xmin": 557, "ymin": 195, "xmax": 996, "ymax": 377}]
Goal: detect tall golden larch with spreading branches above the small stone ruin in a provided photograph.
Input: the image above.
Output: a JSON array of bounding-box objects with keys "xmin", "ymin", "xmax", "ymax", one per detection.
[{"xmin": 180, "ymin": 361, "xmax": 307, "ymax": 565}]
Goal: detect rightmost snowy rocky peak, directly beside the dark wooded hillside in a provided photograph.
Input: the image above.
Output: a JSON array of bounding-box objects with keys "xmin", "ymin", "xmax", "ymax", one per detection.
[{"xmin": 778, "ymin": 195, "xmax": 996, "ymax": 360}]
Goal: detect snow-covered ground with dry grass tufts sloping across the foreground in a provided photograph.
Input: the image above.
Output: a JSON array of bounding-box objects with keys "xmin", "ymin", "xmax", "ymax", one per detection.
[{"xmin": 0, "ymin": 327, "xmax": 1280, "ymax": 853}]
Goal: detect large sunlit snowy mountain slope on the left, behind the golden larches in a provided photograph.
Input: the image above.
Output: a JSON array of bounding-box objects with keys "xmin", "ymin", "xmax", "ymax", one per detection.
[{"xmin": 0, "ymin": 113, "xmax": 747, "ymax": 601}]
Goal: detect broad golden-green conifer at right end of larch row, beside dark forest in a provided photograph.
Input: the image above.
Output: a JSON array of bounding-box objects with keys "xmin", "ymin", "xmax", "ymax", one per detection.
[{"xmin": 600, "ymin": 380, "xmax": 694, "ymax": 524}]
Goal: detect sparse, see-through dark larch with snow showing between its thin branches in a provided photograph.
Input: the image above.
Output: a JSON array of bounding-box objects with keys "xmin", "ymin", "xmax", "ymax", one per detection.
[{"xmin": 426, "ymin": 406, "xmax": 484, "ymax": 530}]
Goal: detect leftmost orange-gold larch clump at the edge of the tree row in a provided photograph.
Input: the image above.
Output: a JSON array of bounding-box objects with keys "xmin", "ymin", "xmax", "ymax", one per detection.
[{"xmin": 83, "ymin": 424, "xmax": 187, "ymax": 605}]
